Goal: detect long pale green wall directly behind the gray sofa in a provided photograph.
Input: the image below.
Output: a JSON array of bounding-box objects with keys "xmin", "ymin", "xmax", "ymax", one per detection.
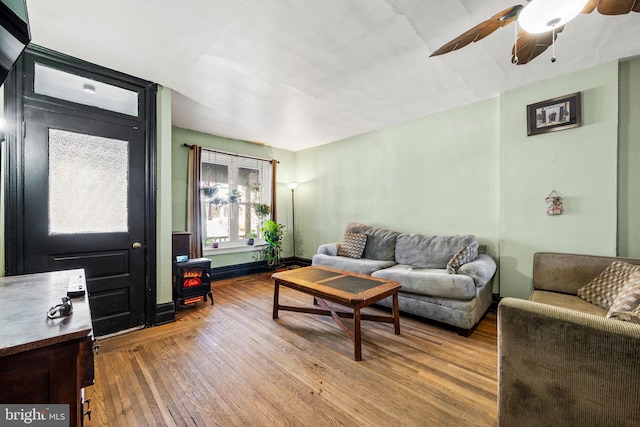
[{"xmin": 296, "ymin": 98, "xmax": 499, "ymax": 266}]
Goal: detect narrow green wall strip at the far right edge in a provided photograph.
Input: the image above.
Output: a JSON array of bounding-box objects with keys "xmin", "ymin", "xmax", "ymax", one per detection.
[{"xmin": 618, "ymin": 58, "xmax": 640, "ymax": 258}]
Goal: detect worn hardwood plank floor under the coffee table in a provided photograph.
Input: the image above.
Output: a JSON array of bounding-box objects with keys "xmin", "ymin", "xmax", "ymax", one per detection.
[{"xmin": 85, "ymin": 274, "xmax": 497, "ymax": 427}]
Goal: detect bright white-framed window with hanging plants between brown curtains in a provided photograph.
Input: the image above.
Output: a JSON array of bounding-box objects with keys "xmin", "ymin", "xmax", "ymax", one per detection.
[{"xmin": 200, "ymin": 149, "xmax": 273, "ymax": 255}]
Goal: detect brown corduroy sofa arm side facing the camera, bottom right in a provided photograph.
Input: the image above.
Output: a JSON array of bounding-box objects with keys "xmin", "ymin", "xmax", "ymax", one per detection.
[{"xmin": 498, "ymin": 298, "xmax": 640, "ymax": 426}]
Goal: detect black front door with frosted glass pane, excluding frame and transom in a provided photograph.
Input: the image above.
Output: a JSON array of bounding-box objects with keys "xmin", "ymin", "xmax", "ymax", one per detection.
[{"xmin": 24, "ymin": 108, "xmax": 146, "ymax": 336}]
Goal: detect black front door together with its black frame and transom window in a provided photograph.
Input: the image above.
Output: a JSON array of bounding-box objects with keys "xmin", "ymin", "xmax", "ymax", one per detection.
[{"xmin": 5, "ymin": 46, "xmax": 156, "ymax": 336}]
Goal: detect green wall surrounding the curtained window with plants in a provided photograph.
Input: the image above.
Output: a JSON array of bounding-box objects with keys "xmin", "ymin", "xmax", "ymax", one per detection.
[{"xmin": 171, "ymin": 127, "xmax": 295, "ymax": 267}]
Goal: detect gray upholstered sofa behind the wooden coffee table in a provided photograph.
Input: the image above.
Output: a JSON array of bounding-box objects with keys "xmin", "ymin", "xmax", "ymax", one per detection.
[{"xmin": 312, "ymin": 222, "xmax": 496, "ymax": 336}]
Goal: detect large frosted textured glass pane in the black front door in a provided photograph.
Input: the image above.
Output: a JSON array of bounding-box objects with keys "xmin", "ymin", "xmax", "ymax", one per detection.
[{"xmin": 49, "ymin": 129, "xmax": 129, "ymax": 235}]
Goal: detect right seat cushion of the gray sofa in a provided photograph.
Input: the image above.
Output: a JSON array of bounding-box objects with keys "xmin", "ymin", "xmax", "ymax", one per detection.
[{"xmin": 372, "ymin": 264, "xmax": 476, "ymax": 300}]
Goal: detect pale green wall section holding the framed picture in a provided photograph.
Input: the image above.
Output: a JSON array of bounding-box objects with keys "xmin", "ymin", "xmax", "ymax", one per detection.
[{"xmin": 499, "ymin": 63, "xmax": 618, "ymax": 298}]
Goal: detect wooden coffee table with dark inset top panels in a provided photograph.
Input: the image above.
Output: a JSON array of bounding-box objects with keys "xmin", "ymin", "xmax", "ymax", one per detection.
[{"xmin": 271, "ymin": 266, "xmax": 400, "ymax": 360}]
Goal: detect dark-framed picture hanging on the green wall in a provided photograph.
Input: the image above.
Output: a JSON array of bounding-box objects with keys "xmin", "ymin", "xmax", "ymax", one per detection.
[{"xmin": 527, "ymin": 92, "xmax": 582, "ymax": 136}]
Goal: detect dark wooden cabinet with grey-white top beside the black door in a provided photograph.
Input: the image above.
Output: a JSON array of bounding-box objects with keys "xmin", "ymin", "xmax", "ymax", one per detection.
[{"xmin": 0, "ymin": 270, "xmax": 94, "ymax": 426}]
